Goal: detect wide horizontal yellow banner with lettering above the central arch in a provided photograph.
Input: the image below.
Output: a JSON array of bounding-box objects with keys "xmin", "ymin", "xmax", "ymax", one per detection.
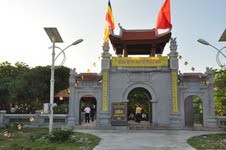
[{"xmin": 112, "ymin": 56, "xmax": 168, "ymax": 67}]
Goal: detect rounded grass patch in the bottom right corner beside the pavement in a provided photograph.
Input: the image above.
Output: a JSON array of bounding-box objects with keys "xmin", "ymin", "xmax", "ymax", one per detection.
[{"xmin": 187, "ymin": 133, "xmax": 226, "ymax": 150}]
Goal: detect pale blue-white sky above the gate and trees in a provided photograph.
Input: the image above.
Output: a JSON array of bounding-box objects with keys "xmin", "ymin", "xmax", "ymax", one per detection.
[{"xmin": 0, "ymin": 0, "xmax": 226, "ymax": 73}]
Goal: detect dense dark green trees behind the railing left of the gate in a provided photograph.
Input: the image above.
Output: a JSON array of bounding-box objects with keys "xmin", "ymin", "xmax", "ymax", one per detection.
[{"xmin": 0, "ymin": 61, "xmax": 70, "ymax": 113}]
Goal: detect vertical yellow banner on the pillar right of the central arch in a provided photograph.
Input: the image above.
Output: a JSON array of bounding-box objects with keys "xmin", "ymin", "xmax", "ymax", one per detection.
[{"xmin": 172, "ymin": 72, "xmax": 178, "ymax": 112}]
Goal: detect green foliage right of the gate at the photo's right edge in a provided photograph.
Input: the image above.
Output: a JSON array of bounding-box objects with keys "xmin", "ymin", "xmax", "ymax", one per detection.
[{"xmin": 213, "ymin": 69, "xmax": 226, "ymax": 116}]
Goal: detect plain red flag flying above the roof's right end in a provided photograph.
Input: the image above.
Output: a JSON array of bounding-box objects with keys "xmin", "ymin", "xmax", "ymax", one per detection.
[{"xmin": 156, "ymin": 0, "xmax": 172, "ymax": 29}]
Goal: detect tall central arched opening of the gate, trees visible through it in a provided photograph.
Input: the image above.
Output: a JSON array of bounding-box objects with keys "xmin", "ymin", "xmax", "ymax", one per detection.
[{"xmin": 127, "ymin": 87, "xmax": 152, "ymax": 124}]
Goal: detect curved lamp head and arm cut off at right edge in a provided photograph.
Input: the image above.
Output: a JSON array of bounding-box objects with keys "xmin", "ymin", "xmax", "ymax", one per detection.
[{"xmin": 197, "ymin": 39, "xmax": 226, "ymax": 69}]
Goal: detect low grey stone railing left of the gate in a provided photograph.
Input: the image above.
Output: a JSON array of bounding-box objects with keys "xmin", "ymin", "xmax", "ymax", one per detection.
[{"xmin": 0, "ymin": 110, "xmax": 68, "ymax": 127}]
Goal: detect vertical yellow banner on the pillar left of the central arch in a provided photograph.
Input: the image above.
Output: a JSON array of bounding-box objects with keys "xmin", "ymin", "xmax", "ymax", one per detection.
[{"xmin": 102, "ymin": 71, "xmax": 108, "ymax": 112}]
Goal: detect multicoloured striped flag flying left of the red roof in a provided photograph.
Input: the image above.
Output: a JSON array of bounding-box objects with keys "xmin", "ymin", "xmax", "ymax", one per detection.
[{"xmin": 104, "ymin": 0, "xmax": 115, "ymax": 42}]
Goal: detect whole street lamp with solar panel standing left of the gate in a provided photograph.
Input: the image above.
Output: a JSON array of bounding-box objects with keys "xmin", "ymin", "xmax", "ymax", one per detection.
[{"xmin": 44, "ymin": 28, "xmax": 83, "ymax": 134}]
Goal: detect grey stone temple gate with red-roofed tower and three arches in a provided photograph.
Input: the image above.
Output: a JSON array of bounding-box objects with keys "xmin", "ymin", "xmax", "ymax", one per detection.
[{"xmin": 68, "ymin": 28, "xmax": 216, "ymax": 128}]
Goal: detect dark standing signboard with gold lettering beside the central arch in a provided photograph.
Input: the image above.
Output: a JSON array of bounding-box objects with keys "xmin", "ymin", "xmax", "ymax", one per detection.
[{"xmin": 111, "ymin": 102, "xmax": 127, "ymax": 126}]
